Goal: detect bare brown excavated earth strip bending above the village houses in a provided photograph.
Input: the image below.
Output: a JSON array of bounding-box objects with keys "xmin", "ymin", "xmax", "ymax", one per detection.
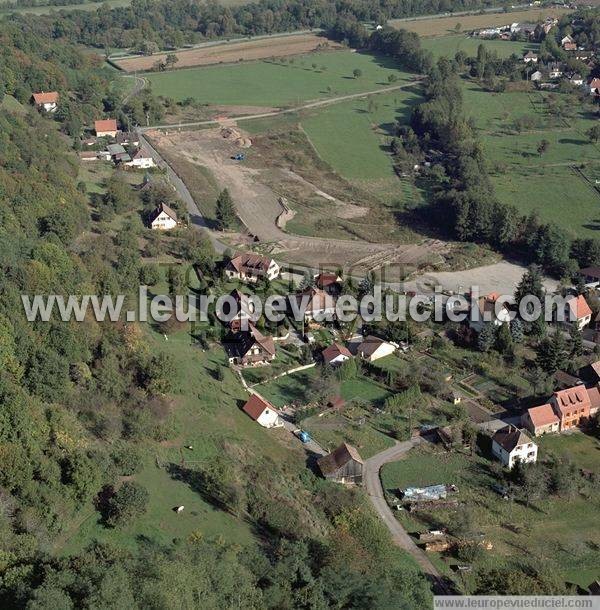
[{"xmin": 146, "ymin": 129, "xmax": 440, "ymax": 270}]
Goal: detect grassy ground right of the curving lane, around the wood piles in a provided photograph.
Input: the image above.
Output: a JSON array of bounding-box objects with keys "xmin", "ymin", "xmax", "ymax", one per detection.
[{"xmin": 382, "ymin": 434, "xmax": 600, "ymax": 587}]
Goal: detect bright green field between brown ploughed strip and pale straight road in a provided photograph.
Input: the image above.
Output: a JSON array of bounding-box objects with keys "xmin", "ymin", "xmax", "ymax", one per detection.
[{"xmin": 146, "ymin": 51, "xmax": 410, "ymax": 107}]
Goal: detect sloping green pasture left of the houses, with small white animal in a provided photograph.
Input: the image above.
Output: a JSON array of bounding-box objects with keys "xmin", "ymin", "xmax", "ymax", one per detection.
[{"xmin": 56, "ymin": 312, "xmax": 297, "ymax": 554}]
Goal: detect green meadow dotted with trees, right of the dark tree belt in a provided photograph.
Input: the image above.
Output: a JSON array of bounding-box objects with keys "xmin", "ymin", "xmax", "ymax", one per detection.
[{"xmin": 464, "ymin": 82, "xmax": 600, "ymax": 237}]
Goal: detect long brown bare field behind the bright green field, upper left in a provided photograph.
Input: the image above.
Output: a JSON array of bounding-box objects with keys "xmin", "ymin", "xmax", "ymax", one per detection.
[{"xmin": 115, "ymin": 34, "xmax": 340, "ymax": 72}]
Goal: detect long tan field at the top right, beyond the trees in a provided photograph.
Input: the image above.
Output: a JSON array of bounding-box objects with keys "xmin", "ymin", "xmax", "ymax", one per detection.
[{"xmin": 389, "ymin": 8, "xmax": 571, "ymax": 37}]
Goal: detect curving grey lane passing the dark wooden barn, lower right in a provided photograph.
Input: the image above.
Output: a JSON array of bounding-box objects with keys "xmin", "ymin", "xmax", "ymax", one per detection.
[{"xmin": 363, "ymin": 436, "xmax": 449, "ymax": 594}]
